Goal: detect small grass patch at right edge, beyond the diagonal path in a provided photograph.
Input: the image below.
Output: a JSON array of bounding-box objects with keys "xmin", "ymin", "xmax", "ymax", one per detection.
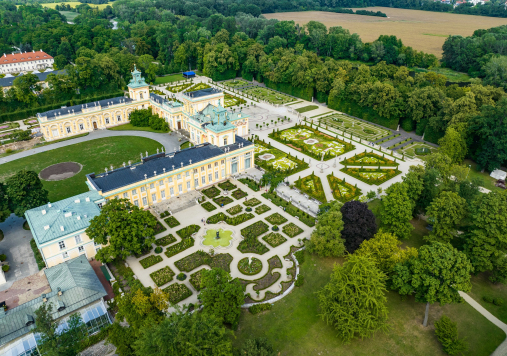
[{"xmin": 468, "ymin": 273, "xmax": 507, "ymax": 323}]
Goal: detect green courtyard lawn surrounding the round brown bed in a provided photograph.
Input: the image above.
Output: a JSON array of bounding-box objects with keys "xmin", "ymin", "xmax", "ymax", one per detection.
[{"xmin": 0, "ymin": 136, "xmax": 161, "ymax": 201}]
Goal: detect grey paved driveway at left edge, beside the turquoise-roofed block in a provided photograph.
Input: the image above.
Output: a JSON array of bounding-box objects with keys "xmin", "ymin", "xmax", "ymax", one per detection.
[{"xmin": 0, "ymin": 214, "xmax": 39, "ymax": 291}]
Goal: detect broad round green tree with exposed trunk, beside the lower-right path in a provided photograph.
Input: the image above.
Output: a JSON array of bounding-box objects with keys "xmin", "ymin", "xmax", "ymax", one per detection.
[{"xmin": 392, "ymin": 242, "xmax": 474, "ymax": 326}]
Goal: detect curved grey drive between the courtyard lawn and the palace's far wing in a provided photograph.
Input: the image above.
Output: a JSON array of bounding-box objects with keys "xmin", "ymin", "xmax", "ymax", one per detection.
[{"xmin": 0, "ymin": 130, "xmax": 187, "ymax": 164}]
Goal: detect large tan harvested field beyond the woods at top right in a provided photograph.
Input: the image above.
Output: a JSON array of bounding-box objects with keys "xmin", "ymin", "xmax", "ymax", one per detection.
[{"xmin": 264, "ymin": 7, "xmax": 507, "ymax": 57}]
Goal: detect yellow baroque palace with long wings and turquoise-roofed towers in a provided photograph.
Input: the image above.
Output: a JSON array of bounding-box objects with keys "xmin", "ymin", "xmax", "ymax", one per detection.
[{"xmin": 25, "ymin": 70, "xmax": 254, "ymax": 267}]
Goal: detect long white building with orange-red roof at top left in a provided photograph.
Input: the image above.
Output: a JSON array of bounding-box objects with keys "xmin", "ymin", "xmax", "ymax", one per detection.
[{"xmin": 0, "ymin": 50, "xmax": 55, "ymax": 74}]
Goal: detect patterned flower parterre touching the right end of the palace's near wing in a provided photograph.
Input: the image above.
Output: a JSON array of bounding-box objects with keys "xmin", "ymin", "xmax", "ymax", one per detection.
[{"xmin": 255, "ymin": 140, "xmax": 308, "ymax": 175}]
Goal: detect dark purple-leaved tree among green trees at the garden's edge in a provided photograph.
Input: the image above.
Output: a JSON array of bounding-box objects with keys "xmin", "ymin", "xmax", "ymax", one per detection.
[{"xmin": 340, "ymin": 200, "xmax": 377, "ymax": 253}]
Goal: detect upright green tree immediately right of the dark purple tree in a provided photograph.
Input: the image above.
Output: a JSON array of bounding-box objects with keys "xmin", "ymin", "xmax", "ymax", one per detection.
[{"xmin": 380, "ymin": 183, "xmax": 414, "ymax": 239}]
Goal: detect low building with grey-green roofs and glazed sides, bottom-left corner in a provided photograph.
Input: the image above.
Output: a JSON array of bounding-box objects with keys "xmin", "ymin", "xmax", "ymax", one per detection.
[{"xmin": 0, "ymin": 255, "xmax": 111, "ymax": 356}]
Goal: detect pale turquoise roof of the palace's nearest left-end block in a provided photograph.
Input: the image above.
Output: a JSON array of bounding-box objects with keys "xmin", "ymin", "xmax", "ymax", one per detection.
[{"xmin": 25, "ymin": 191, "xmax": 104, "ymax": 245}]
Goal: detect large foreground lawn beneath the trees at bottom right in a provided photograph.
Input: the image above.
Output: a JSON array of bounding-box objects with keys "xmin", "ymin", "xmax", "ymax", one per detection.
[{"xmin": 233, "ymin": 253, "xmax": 505, "ymax": 356}]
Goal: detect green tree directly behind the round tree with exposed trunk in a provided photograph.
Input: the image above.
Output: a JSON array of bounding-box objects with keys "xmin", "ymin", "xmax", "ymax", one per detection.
[{"xmin": 426, "ymin": 192, "xmax": 467, "ymax": 242}]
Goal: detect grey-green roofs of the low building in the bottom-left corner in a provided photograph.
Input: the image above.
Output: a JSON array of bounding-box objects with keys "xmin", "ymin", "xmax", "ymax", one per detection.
[{"xmin": 0, "ymin": 255, "xmax": 107, "ymax": 346}]
